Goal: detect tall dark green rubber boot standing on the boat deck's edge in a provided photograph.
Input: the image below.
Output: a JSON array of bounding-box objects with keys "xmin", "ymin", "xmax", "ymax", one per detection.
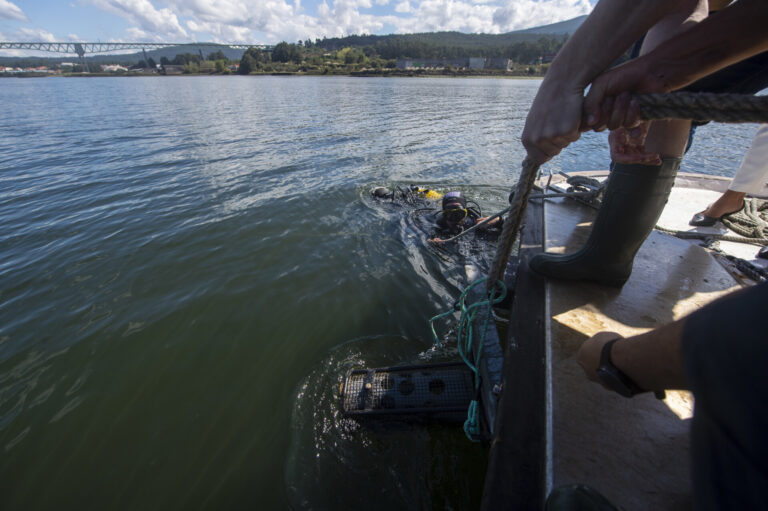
[{"xmin": 529, "ymin": 158, "xmax": 680, "ymax": 287}]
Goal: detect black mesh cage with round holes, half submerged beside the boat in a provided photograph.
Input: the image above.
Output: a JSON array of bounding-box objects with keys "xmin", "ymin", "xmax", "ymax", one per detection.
[{"xmin": 340, "ymin": 362, "xmax": 475, "ymax": 421}]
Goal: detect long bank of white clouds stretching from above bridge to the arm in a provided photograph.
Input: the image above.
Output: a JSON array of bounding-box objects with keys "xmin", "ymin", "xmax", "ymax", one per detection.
[{"xmin": 60, "ymin": 0, "xmax": 592, "ymax": 44}]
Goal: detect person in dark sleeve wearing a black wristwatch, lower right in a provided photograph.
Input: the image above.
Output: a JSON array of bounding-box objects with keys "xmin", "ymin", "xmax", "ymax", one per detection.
[{"xmin": 578, "ymin": 282, "xmax": 768, "ymax": 510}]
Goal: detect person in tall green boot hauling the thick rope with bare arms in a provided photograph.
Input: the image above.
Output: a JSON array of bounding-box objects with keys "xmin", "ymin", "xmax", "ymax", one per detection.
[{"xmin": 522, "ymin": 0, "xmax": 766, "ymax": 286}]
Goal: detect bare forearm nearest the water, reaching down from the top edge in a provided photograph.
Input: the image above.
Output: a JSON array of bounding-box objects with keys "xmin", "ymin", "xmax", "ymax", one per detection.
[{"xmin": 544, "ymin": 0, "xmax": 696, "ymax": 90}]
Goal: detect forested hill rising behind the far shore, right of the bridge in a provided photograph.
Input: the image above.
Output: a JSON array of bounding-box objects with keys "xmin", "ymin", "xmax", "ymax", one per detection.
[{"xmin": 310, "ymin": 16, "xmax": 586, "ymax": 58}]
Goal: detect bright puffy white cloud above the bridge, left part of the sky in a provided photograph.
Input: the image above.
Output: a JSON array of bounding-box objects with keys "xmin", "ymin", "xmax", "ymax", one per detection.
[{"xmin": 90, "ymin": 0, "xmax": 187, "ymax": 40}]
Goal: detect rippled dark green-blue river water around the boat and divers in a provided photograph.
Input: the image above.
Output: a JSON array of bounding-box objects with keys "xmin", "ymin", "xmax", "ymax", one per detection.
[{"xmin": 0, "ymin": 76, "xmax": 755, "ymax": 510}]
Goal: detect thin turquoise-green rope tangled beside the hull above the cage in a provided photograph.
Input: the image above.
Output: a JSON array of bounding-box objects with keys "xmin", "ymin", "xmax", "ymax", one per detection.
[{"xmin": 429, "ymin": 277, "xmax": 507, "ymax": 442}]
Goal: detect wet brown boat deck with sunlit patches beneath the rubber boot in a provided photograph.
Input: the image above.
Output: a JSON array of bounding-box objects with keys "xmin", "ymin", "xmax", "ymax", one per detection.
[{"xmin": 483, "ymin": 173, "xmax": 765, "ymax": 511}]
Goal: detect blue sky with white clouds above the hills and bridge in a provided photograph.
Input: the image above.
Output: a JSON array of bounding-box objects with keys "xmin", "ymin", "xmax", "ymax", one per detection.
[{"xmin": 0, "ymin": 0, "xmax": 597, "ymax": 56}]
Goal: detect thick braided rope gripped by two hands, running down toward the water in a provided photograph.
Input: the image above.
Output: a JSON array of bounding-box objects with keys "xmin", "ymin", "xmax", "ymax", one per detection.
[{"xmin": 486, "ymin": 92, "xmax": 768, "ymax": 292}]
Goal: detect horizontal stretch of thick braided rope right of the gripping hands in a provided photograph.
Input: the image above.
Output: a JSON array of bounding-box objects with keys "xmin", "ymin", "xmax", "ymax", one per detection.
[{"xmin": 633, "ymin": 92, "xmax": 768, "ymax": 123}]
